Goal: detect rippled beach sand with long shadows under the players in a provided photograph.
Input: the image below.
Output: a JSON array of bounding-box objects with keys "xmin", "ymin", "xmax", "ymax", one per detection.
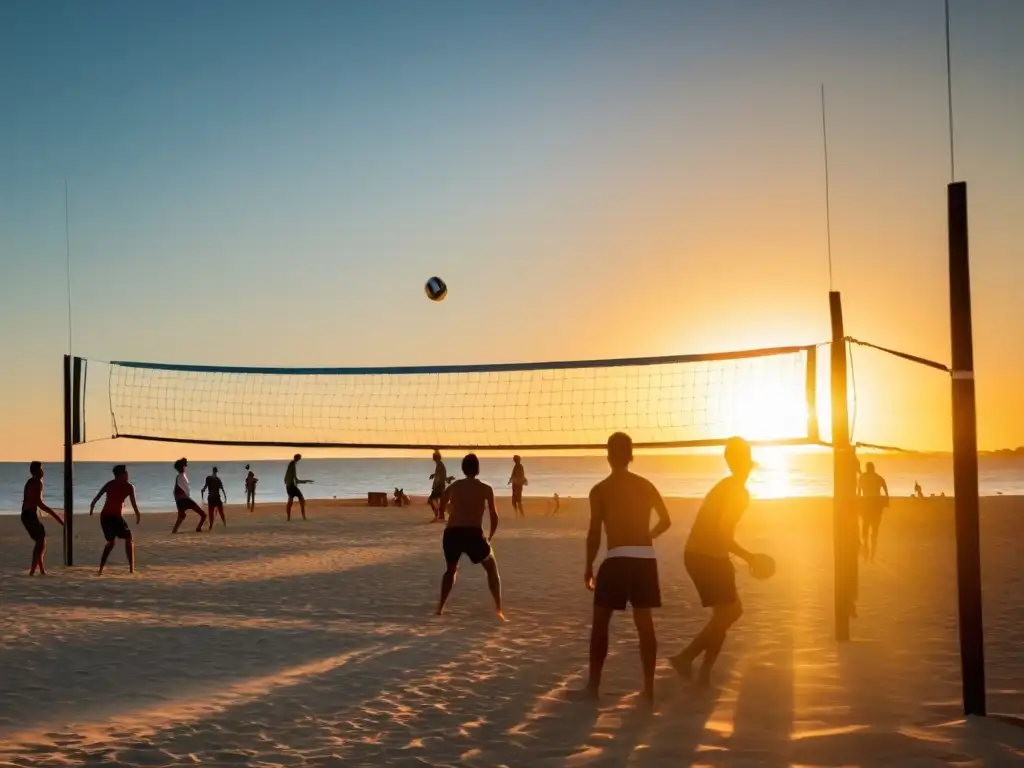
[{"xmin": 0, "ymin": 498, "xmax": 1024, "ymax": 766}]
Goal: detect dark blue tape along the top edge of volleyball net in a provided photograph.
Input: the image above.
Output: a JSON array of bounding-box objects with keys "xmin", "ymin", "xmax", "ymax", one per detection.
[{"xmin": 111, "ymin": 344, "xmax": 816, "ymax": 376}]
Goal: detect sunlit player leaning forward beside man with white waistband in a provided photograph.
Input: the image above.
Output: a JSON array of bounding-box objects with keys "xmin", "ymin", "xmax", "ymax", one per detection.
[{"xmin": 669, "ymin": 437, "xmax": 774, "ymax": 687}]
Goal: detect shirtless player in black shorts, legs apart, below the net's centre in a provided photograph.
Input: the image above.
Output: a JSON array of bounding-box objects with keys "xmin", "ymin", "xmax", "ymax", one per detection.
[{"xmin": 437, "ymin": 454, "xmax": 505, "ymax": 622}]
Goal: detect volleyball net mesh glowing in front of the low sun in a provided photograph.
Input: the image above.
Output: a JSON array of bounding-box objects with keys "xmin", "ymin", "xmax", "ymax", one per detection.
[{"xmin": 99, "ymin": 347, "xmax": 813, "ymax": 449}]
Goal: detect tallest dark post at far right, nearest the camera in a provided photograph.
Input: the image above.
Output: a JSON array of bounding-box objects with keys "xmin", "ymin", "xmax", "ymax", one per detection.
[{"xmin": 946, "ymin": 181, "xmax": 985, "ymax": 716}]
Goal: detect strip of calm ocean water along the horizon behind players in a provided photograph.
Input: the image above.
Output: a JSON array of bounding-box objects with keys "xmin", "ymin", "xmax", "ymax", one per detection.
[{"xmin": 0, "ymin": 450, "xmax": 1024, "ymax": 514}]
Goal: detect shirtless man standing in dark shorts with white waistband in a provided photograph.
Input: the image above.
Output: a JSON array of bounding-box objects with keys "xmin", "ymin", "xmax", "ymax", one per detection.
[{"xmin": 571, "ymin": 432, "xmax": 672, "ymax": 705}]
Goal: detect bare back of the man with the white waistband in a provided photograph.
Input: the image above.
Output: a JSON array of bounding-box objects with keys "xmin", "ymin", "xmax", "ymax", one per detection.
[{"xmin": 590, "ymin": 470, "xmax": 660, "ymax": 550}]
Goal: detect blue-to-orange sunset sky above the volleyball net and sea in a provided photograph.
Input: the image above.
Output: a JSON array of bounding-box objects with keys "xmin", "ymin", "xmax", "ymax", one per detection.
[{"xmin": 0, "ymin": 0, "xmax": 1024, "ymax": 461}]
